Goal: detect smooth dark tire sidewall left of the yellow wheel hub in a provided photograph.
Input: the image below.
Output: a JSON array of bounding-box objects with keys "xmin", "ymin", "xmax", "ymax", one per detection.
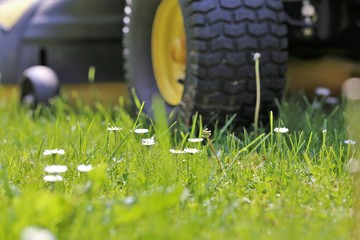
[{"xmin": 123, "ymin": 0, "xmax": 165, "ymax": 115}]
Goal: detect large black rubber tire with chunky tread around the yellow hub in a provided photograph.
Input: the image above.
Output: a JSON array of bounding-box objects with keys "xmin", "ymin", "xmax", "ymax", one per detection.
[{"xmin": 124, "ymin": 0, "xmax": 288, "ymax": 126}]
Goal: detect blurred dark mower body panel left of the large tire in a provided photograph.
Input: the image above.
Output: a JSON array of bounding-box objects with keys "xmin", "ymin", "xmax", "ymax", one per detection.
[{"xmin": 0, "ymin": 0, "xmax": 124, "ymax": 103}]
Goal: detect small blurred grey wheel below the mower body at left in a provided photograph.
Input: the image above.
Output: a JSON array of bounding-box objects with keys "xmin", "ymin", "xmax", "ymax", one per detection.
[{"xmin": 20, "ymin": 66, "xmax": 60, "ymax": 108}]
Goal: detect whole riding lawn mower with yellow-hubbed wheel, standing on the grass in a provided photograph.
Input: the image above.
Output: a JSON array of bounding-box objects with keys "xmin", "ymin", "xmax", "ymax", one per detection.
[{"xmin": 0, "ymin": 0, "xmax": 360, "ymax": 126}]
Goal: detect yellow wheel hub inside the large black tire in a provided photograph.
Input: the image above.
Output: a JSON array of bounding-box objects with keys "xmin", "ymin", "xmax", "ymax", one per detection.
[{"xmin": 151, "ymin": 0, "xmax": 186, "ymax": 106}]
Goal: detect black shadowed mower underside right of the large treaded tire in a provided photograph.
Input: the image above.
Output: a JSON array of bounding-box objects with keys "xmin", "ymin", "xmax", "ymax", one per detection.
[{"xmin": 283, "ymin": 0, "xmax": 360, "ymax": 60}]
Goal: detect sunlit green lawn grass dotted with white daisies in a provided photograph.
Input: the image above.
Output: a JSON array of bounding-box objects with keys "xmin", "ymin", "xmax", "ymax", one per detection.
[{"xmin": 0, "ymin": 90, "xmax": 357, "ymax": 239}]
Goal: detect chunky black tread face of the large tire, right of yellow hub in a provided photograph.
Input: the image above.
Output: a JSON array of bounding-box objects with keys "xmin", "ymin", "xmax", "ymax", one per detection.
[{"xmin": 179, "ymin": 0, "xmax": 288, "ymax": 126}]
